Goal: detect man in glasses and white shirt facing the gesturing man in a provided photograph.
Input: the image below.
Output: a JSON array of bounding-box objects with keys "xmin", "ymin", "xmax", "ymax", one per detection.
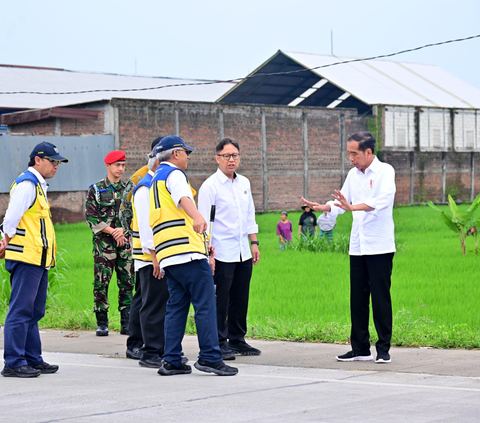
[{"xmin": 198, "ymin": 138, "xmax": 261, "ymax": 360}]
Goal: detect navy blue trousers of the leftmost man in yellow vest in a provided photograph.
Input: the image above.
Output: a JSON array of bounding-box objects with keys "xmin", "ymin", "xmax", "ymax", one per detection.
[{"xmin": 4, "ymin": 260, "xmax": 48, "ymax": 368}]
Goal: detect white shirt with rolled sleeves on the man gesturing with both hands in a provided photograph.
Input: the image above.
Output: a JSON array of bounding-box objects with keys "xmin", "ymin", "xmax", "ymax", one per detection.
[{"xmin": 327, "ymin": 157, "xmax": 396, "ymax": 256}]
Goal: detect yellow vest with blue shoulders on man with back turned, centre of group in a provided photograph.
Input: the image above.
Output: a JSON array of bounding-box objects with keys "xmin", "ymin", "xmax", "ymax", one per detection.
[{"xmin": 150, "ymin": 164, "xmax": 207, "ymax": 263}]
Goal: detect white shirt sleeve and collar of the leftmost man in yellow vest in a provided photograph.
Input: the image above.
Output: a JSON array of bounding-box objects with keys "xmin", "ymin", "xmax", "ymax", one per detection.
[{"xmin": 3, "ymin": 167, "xmax": 48, "ymax": 238}]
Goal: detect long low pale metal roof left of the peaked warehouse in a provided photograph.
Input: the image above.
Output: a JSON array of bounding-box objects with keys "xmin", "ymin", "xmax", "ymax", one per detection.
[{"xmin": 0, "ymin": 66, "xmax": 233, "ymax": 109}]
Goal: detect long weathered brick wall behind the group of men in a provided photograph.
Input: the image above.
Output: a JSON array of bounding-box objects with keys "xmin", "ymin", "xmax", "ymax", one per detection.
[{"xmin": 112, "ymin": 99, "xmax": 366, "ymax": 211}]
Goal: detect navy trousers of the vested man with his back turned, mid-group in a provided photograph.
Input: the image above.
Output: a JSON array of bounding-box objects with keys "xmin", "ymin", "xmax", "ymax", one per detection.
[{"xmin": 163, "ymin": 259, "xmax": 222, "ymax": 367}]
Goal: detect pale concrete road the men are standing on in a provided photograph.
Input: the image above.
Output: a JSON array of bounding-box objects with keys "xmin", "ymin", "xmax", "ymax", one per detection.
[{"xmin": 0, "ymin": 331, "xmax": 480, "ymax": 423}]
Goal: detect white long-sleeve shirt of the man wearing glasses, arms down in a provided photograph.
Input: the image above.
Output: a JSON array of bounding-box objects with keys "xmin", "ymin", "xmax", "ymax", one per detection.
[{"xmin": 198, "ymin": 169, "xmax": 258, "ymax": 263}]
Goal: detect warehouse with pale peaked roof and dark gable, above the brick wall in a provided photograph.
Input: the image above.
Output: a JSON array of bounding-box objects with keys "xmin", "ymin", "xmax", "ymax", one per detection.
[{"xmin": 218, "ymin": 51, "xmax": 480, "ymax": 203}]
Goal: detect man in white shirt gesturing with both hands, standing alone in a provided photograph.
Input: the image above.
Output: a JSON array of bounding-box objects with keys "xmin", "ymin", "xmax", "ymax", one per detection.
[{"xmin": 302, "ymin": 132, "xmax": 396, "ymax": 363}]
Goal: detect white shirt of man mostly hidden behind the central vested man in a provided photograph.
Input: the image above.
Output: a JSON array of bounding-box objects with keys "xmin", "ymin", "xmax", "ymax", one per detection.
[{"xmin": 133, "ymin": 170, "xmax": 155, "ymax": 272}]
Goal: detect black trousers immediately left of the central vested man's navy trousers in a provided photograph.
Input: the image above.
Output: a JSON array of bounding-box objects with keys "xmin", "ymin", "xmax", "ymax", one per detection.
[{"xmin": 138, "ymin": 266, "xmax": 169, "ymax": 359}]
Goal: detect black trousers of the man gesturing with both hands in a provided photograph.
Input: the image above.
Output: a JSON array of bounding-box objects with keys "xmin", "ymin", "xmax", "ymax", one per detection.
[{"xmin": 350, "ymin": 253, "xmax": 394, "ymax": 355}]
